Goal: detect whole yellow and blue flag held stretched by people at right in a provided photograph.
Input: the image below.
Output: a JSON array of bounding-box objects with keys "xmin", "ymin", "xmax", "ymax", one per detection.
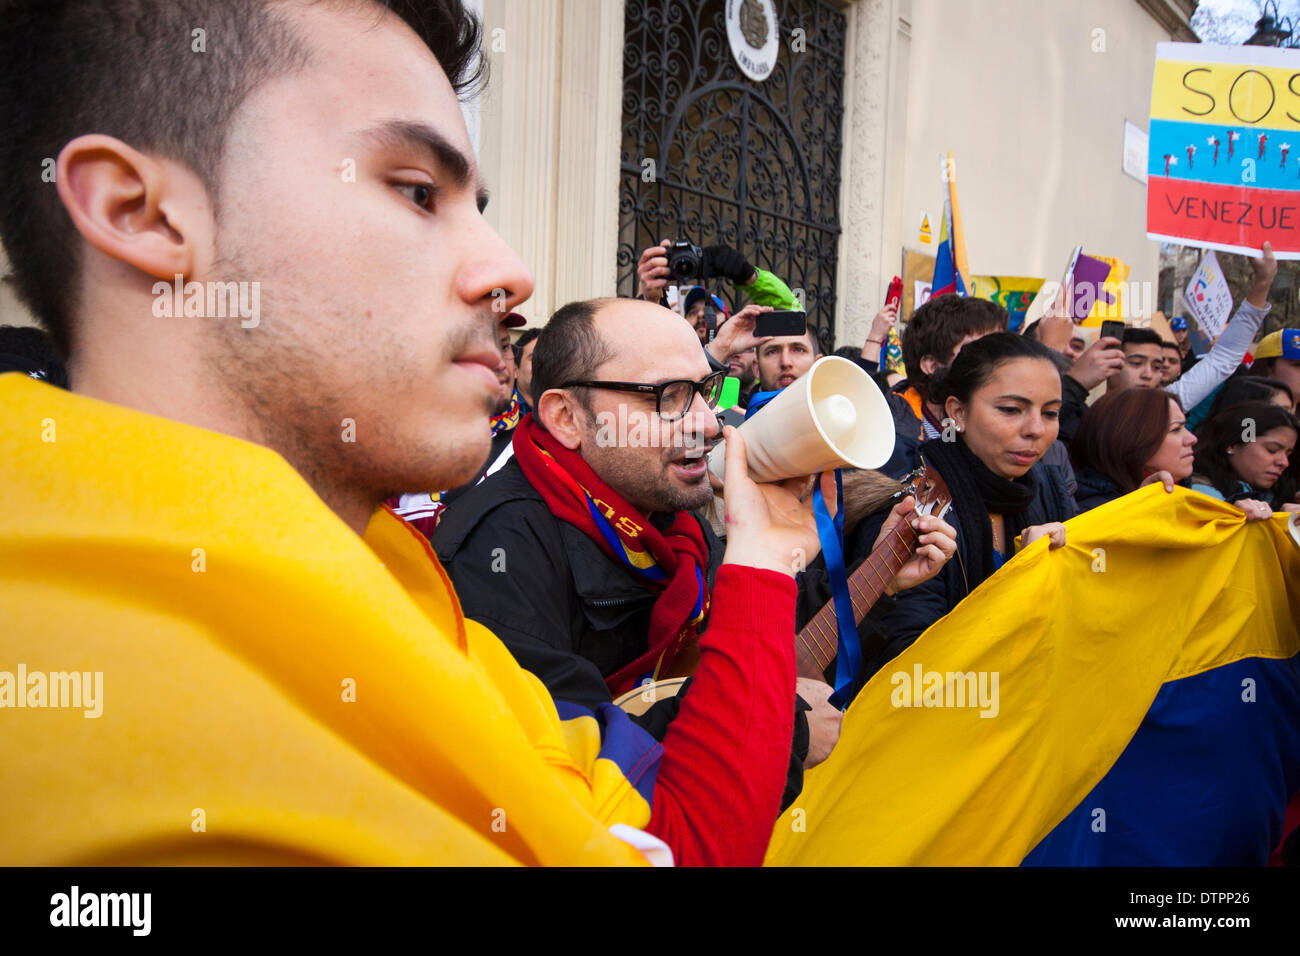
[{"xmin": 767, "ymin": 485, "xmax": 1300, "ymax": 865}]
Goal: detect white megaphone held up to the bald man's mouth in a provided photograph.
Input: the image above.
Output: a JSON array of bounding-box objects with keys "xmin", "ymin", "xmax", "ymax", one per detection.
[{"xmin": 709, "ymin": 355, "xmax": 894, "ymax": 483}]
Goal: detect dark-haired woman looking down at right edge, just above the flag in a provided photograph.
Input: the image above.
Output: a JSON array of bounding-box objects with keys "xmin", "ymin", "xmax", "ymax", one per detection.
[{"xmin": 1192, "ymin": 402, "xmax": 1300, "ymax": 516}]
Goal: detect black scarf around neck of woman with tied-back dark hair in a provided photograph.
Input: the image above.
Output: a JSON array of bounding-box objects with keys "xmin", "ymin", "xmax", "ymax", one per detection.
[{"xmin": 920, "ymin": 436, "xmax": 1037, "ymax": 593}]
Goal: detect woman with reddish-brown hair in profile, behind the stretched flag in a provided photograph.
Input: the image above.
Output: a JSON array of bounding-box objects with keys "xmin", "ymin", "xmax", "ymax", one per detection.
[{"xmin": 1070, "ymin": 389, "xmax": 1196, "ymax": 511}]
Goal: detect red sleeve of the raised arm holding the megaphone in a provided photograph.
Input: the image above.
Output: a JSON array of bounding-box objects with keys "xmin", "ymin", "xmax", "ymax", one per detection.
[{"xmin": 646, "ymin": 564, "xmax": 796, "ymax": 866}]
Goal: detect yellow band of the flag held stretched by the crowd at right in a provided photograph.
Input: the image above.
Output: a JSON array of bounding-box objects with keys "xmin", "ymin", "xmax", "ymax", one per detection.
[{"xmin": 767, "ymin": 485, "xmax": 1300, "ymax": 865}]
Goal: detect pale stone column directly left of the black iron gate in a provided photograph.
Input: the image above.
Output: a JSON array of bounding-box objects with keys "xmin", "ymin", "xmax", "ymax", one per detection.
[{"xmin": 478, "ymin": 0, "xmax": 623, "ymax": 325}]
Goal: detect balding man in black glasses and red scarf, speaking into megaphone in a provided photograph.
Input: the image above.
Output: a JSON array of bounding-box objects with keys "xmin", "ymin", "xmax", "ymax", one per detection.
[{"xmin": 433, "ymin": 299, "xmax": 946, "ymax": 799}]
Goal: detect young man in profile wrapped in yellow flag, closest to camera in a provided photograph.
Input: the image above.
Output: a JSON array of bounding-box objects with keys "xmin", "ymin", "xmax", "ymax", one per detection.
[{"xmin": 0, "ymin": 0, "xmax": 816, "ymax": 865}]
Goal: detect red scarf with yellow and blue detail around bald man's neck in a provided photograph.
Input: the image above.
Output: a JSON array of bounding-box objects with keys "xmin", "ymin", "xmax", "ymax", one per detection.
[{"xmin": 515, "ymin": 415, "xmax": 710, "ymax": 696}]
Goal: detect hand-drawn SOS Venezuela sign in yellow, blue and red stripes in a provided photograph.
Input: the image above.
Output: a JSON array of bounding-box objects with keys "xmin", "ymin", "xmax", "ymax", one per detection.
[{"xmin": 1147, "ymin": 43, "xmax": 1300, "ymax": 259}]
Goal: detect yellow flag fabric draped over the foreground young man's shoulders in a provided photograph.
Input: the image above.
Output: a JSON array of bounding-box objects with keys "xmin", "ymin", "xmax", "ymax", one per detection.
[{"xmin": 0, "ymin": 375, "xmax": 650, "ymax": 865}]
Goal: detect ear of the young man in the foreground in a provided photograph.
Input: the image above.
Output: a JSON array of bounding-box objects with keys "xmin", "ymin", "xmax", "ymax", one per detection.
[{"xmin": 55, "ymin": 134, "xmax": 211, "ymax": 280}]
